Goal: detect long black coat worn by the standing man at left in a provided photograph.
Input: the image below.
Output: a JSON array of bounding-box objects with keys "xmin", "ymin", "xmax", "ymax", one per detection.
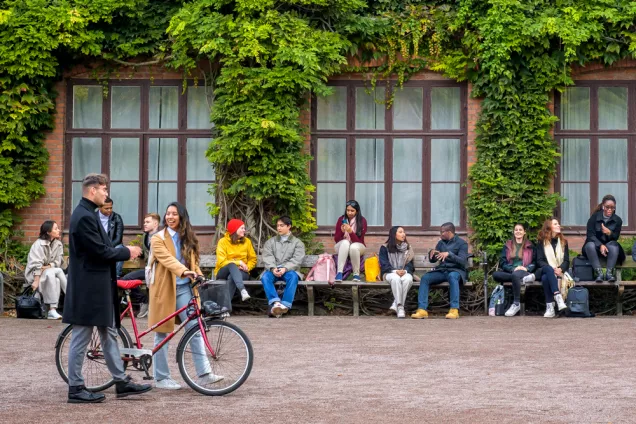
[{"xmin": 62, "ymin": 198, "xmax": 130, "ymax": 327}]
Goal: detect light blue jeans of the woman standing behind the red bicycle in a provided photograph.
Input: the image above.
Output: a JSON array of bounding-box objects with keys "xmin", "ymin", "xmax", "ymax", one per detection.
[{"xmin": 153, "ymin": 284, "xmax": 212, "ymax": 381}]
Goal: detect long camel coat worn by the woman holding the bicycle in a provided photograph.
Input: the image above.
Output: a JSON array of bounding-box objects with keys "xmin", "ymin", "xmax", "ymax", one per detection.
[{"xmin": 148, "ymin": 228, "xmax": 203, "ymax": 333}]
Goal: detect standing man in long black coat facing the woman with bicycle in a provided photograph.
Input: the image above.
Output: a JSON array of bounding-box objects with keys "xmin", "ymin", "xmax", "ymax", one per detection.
[{"xmin": 63, "ymin": 174, "xmax": 152, "ymax": 403}]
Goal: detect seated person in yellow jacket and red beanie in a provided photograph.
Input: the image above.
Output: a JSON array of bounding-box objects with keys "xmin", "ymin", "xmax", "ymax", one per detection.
[{"xmin": 214, "ymin": 219, "xmax": 257, "ymax": 301}]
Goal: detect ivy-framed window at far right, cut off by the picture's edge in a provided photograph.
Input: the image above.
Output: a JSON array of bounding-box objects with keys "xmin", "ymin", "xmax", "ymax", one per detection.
[{"xmin": 555, "ymin": 81, "xmax": 636, "ymax": 229}]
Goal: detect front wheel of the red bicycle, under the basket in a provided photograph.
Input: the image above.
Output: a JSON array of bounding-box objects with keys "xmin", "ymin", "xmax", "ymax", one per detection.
[{"xmin": 177, "ymin": 318, "xmax": 254, "ymax": 396}]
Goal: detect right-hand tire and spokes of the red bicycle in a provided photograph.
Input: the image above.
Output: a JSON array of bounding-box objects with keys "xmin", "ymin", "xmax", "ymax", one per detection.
[{"xmin": 177, "ymin": 318, "xmax": 254, "ymax": 396}]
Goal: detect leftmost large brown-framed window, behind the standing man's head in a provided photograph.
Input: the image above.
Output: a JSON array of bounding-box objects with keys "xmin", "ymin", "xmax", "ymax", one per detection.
[{"xmin": 65, "ymin": 80, "xmax": 215, "ymax": 228}]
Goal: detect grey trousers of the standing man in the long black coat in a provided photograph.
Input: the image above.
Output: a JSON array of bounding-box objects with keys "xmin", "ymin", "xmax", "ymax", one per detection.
[{"xmin": 68, "ymin": 325, "xmax": 126, "ymax": 386}]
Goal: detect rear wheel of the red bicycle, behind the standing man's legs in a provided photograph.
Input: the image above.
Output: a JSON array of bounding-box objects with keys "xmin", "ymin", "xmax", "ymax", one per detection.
[{"xmin": 55, "ymin": 324, "xmax": 132, "ymax": 392}]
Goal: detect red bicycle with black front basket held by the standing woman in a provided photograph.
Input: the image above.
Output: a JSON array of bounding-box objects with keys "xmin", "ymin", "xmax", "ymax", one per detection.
[{"xmin": 55, "ymin": 277, "xmax": 254, "ymax": 396}]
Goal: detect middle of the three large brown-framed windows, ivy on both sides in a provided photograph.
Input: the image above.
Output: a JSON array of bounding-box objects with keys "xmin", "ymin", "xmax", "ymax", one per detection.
[{"xmin": 311, "ymin": 81, "xmax": 466, "ymax": 231}]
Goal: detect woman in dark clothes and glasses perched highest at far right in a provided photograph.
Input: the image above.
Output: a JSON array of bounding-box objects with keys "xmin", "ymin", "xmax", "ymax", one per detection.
[{"xmin": 583, "ymin": 194, "xmax": 625, "ymax": 283}]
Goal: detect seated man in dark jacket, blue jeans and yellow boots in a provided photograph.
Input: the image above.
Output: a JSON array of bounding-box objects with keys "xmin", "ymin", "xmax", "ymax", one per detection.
[{"xmin": 411, "ymin": 222, "xmax": 468, "ymax": 319}]
